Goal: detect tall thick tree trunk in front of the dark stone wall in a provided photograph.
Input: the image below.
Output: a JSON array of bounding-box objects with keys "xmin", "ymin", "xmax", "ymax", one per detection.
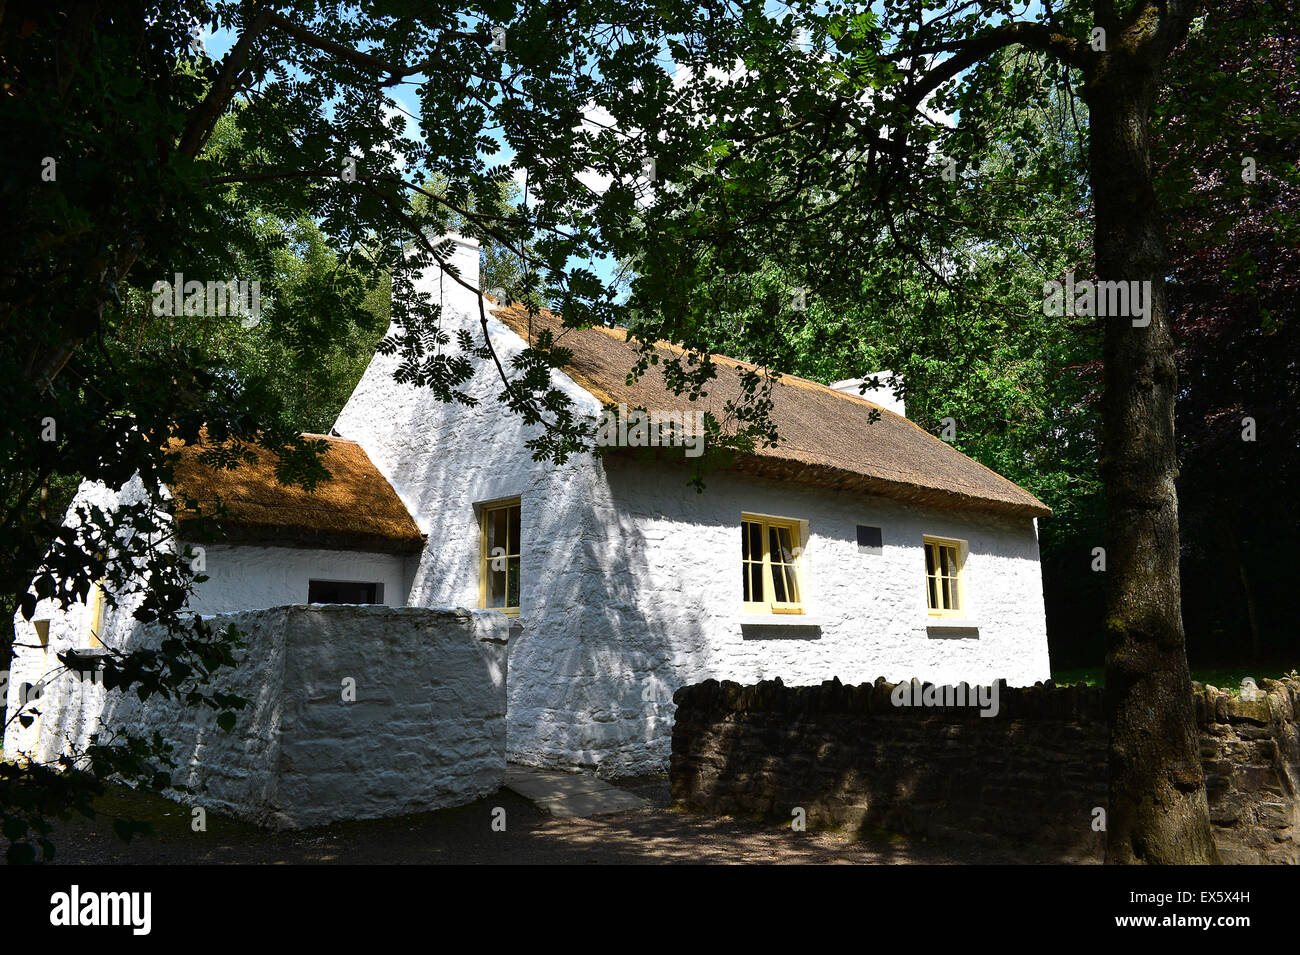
[{"xmin": 1086, "ymin": 61, "xmax": 1218, "ymax": 864}]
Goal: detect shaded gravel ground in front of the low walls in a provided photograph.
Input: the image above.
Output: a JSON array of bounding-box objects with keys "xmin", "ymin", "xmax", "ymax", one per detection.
[{"xmin": 40, "ymin": 777, "xmax": 1081, "ymax": 865}]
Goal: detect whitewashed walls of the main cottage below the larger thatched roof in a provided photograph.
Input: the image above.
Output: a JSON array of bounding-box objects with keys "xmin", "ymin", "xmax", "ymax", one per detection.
[{"xmin": 334, "ymin": 237, "xmax": 1049, "ymax": 776}]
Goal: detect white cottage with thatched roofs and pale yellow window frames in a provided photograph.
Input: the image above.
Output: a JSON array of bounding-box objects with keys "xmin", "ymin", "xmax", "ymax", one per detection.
[{"xmin": 7, "ymin": 231, "xmax": 1049, "ymax": 776}]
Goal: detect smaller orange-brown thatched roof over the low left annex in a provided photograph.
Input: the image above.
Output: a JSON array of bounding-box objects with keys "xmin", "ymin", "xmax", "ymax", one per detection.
[{"xmin": 172, "ymin": 434, "xmax": 424, "ymax": 554}]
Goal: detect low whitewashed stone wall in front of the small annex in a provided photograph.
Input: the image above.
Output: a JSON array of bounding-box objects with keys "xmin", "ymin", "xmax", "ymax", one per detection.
[{"xmin": 5, "ymin": 604, "xmax": 510, "ymax": 826}]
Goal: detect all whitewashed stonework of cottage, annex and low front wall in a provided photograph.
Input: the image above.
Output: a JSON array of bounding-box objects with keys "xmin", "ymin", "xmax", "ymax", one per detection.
[{"xmin": 5, "ymin": 233, "xmax": 1049, "ymax": 805}]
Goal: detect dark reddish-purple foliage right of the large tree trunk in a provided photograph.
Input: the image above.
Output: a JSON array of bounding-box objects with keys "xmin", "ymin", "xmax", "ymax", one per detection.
[{"xmin": 1156, "ymin": 0, "xmax": 1300, "ymax": 660}]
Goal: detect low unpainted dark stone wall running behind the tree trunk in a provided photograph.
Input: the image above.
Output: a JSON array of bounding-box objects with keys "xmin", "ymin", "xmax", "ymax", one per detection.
[{"xmin": 671, "ymin": 677, "xmax": 1300, "ymax": 863}]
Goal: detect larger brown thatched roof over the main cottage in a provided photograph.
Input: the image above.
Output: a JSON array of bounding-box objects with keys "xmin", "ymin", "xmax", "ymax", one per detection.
[{"xmin": 493, "ymin": 305, "xmax": 1052, "ymax": 517}]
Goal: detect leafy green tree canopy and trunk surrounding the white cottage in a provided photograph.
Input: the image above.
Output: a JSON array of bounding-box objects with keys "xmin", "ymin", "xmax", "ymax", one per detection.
[{"xmin": 0, "ymin": 0, "xmax": 1295, "ymax": 861}]
